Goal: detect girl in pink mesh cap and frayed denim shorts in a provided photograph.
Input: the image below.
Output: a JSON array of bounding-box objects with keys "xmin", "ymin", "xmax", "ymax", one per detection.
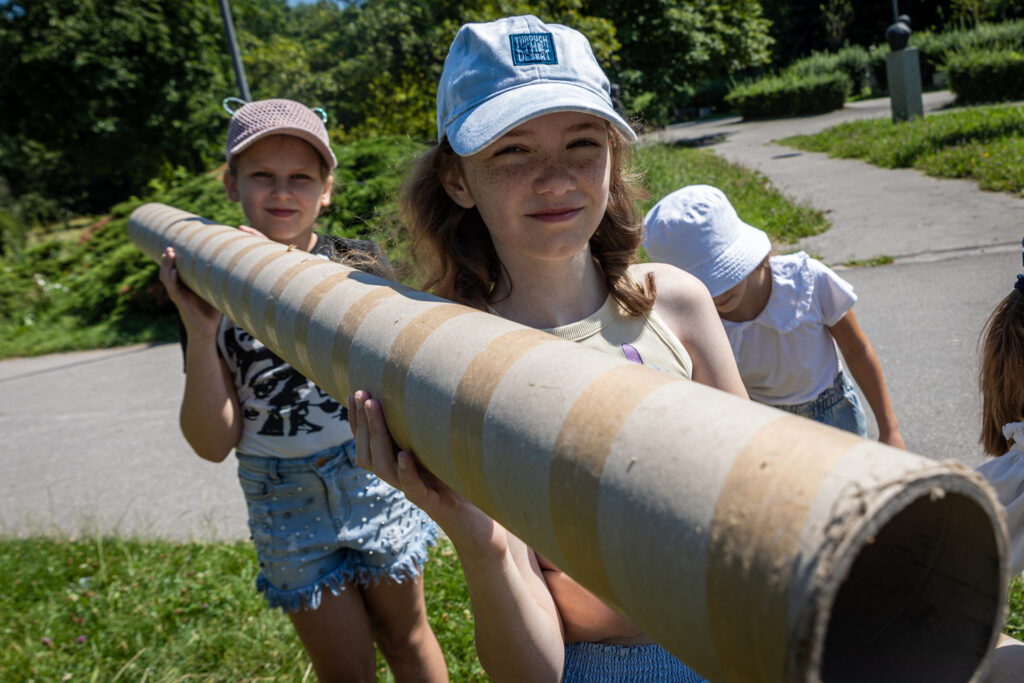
[{"xmin": 160, "ymin": 99, "xmax": 447, "ymax": 682}]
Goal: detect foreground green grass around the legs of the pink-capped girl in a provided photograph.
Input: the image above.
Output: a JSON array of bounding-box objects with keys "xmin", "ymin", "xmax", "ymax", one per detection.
[{"xmin": 0, "ymin": 538, "xmax": 487, "ymax": 682}]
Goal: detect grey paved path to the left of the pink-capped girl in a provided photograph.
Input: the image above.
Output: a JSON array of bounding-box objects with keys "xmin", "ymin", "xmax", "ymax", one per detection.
[{"xmin": 0, "ymin": 344, "xmax": 248, "ymax": 540}]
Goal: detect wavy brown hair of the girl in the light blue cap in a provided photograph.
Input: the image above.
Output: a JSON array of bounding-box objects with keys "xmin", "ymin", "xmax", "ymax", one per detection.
[{"xmin": 398, "ymin": 126, "xmax": 655, "ymax": 315}]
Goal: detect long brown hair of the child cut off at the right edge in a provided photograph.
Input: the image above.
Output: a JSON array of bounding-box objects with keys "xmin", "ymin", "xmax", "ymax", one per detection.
[{"xmin": 979, "ymin": 289, "xmax": 1024, "ymax": 456}]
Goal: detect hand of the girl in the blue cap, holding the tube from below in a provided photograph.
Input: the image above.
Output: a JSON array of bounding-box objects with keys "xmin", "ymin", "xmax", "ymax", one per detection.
[{"xmin": 348, "ymin": 390, "xmax": 508, "ymax": 562}]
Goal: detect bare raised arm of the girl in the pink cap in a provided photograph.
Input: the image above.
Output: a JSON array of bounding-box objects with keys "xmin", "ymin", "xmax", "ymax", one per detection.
[{"xmin": 160, "ymin": 247, "xmax": 242, "ymax": 463}]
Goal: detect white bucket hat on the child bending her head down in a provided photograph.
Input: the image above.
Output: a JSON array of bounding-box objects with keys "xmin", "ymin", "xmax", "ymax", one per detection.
[{"xmin": 643, "ymin": 185, "xmax": 771, "ymax": 297}]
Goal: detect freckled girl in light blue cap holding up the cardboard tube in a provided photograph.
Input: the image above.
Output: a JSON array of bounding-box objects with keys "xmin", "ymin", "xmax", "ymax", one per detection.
[{"xmin": 349, "ymin": 16, "xmax": 745, "ymax": 682}]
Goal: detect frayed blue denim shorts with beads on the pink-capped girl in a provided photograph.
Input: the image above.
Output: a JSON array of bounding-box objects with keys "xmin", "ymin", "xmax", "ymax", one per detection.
[{"xmin": 237, "ymin": 440, "xmax": 437, "ymax": 611}]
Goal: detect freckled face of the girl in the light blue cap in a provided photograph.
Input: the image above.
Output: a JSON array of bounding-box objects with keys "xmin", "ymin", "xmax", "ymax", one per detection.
[{"xmin": 445, "ymin": 112, "xmax": 610, "ymax": 265}]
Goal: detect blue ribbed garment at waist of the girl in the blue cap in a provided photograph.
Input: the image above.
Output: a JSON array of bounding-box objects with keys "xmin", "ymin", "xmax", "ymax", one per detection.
[{"xmin": 562, "ymin": 643, "xmax": 706, "ymax": 683}]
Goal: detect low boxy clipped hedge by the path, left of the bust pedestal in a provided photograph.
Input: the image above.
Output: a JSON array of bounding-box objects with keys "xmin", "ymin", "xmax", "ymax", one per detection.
[{"xmin": 725, "ymin": 72, "xmax": 851, "ymax": 120}]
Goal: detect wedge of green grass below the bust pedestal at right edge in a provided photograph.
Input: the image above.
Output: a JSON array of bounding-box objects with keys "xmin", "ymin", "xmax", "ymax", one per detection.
[{"xmin": 779, "ymin": 104, "xmax": 1024, "ymax": 195}]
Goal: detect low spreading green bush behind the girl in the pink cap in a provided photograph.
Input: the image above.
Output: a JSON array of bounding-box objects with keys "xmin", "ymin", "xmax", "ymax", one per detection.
[{"xmin": 0, "ymin": 137, "xmax": 422, "ymax": 357}]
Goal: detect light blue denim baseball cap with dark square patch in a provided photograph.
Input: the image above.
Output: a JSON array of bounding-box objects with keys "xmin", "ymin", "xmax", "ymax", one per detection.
[{"xmin": 437, "ymin": 14, "xmax": 636, "ymax": 157}]
